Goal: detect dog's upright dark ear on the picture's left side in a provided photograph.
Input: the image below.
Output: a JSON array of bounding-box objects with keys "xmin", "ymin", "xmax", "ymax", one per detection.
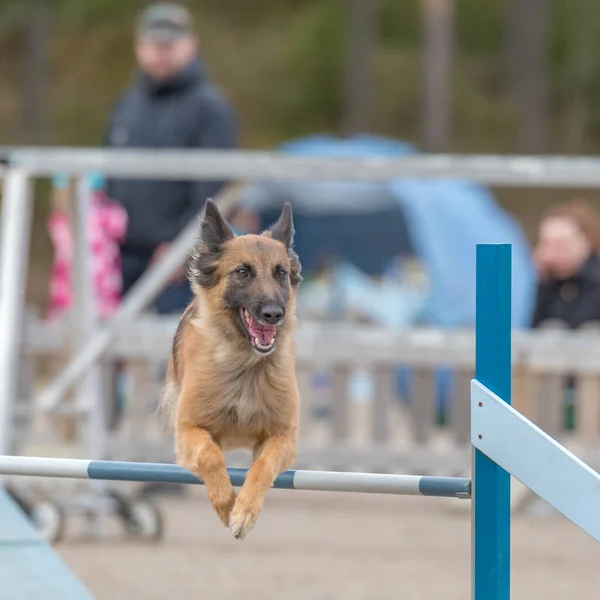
[{"xmin": 189, "ymin": 200, "xmax": 235, "ymax": 287}]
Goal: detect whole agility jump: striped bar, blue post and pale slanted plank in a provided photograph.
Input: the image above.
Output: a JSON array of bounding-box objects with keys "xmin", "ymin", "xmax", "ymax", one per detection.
[{"xmin": 0, "ymin": 244, "xmax": 600, "ymax": 600}]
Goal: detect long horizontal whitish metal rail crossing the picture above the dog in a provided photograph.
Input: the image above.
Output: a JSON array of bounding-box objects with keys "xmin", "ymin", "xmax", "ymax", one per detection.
[{"xmin": 5, "ymin": 148, "xmax": 600, "ymax": 188}]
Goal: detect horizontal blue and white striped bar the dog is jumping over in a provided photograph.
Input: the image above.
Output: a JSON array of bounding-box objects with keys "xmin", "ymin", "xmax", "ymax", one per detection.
[{"xmin": 0, "ymin": 456, "xmax": 471, "ymax": 499}]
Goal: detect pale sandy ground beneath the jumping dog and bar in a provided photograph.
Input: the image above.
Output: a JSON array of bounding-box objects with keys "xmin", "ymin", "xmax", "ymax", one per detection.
[{"xmin": 57, "ymin": 488, "xmax": 600, "ymax": 600}]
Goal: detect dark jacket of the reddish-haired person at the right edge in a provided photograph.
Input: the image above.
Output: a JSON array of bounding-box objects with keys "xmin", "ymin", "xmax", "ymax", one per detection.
[{"xmin": 532, "ymin": 256, "xmax": 600, "ymax": 329}]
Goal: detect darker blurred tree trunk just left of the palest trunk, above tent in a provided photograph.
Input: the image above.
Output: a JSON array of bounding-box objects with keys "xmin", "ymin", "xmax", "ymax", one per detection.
[{"xmin": 343, "ymin": 0, "xmax": 377, "ymax": 135}]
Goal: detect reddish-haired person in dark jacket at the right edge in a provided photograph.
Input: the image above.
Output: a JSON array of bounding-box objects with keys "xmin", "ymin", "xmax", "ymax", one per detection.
[{"xmin": 532, "ymin": 201, "xmax": 600, "ymax": 329}]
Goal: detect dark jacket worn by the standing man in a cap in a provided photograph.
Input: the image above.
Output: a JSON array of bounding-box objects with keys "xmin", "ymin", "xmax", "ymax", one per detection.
[{"xmin": 104, "ymin": 60, "xmax": 237, "ymax": 253}]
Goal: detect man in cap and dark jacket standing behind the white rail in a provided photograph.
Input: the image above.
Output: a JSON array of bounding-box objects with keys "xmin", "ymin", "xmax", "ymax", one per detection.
[{"xmin": 105, "ymin": 3, "xmax": 237, "ymax": 313}]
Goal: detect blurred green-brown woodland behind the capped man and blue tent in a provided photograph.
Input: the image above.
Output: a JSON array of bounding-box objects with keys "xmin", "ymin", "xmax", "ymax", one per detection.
[{"xmin": 0, "ymin": 0, "xmax": 600, "ymax": 302}]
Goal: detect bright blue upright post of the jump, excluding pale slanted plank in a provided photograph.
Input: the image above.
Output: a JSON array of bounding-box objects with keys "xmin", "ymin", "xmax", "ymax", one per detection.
[{"xmin": 472, "ymin": 244, "xmax": 511, "ymax": 600}]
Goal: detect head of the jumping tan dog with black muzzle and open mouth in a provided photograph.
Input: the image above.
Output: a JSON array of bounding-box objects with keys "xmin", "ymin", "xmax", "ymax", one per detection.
[{"xmin": 190, "ymin": 200, "xmax": 302, "ymax": 356}]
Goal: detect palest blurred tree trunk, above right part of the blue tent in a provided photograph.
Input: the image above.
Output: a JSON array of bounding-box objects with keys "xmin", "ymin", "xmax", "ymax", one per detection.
[{"xmin": 421, "ymin": 0, "xmax": 454, "ymax": 152}]
